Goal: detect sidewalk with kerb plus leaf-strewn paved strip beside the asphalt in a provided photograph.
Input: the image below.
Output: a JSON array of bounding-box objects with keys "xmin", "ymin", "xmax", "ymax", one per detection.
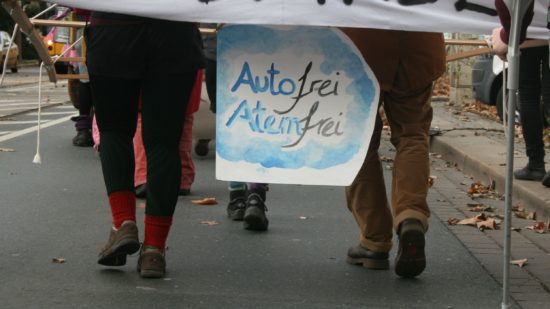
[{"xmin": 429, "ymin": 88, "xmax": 550, "ymax": 308}]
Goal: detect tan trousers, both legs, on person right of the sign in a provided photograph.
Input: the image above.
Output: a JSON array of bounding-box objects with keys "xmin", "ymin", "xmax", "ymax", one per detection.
[{"xmin": 346, "ymin": 79, "xmax": 432, "ymax": 252}]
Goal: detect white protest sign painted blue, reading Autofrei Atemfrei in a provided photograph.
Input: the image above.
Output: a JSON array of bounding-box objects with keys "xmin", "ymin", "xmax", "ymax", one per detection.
[{"xmin": 216, "ymin": 25, "xmax": 380, "ymax": 185}]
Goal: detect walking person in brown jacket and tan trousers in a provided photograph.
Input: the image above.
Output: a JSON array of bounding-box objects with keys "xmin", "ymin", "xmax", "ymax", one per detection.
[{"xmin": 343, "ymin": 28, "xmax": 445, "ymax": 278}]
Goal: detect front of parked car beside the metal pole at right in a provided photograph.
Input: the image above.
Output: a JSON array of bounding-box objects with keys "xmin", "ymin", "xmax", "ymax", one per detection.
[{"xmin": 472, "ymin": 54, "xmax": 519, "ymax": 123}]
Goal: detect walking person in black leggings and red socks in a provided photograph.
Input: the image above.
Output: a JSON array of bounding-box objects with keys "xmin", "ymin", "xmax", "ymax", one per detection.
[{"xmin": 86, "ymin": 12, "xmax": 204, "ymax": 278}]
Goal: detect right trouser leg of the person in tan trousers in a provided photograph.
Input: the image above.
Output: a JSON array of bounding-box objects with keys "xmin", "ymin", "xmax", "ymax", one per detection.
[{"xmin": 384, "ymin": 78, "xmax": 433, "ymax": 229}]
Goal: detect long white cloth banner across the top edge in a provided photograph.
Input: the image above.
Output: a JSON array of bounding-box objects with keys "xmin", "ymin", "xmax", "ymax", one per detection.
[{"xmin": 53, "ymin": 0, "xmax": 549, "ymax": 39}]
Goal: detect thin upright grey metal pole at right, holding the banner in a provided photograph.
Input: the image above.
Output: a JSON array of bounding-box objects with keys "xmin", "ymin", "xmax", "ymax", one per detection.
[{"xmin": 502, "ymin": 0, "xmax": 532, "ymax": 309}]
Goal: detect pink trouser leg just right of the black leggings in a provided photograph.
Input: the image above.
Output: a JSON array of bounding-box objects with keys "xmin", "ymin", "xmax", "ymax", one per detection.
[{"xmin": 179, "ymin": 114, "xmax": 195, "ymax": 195}]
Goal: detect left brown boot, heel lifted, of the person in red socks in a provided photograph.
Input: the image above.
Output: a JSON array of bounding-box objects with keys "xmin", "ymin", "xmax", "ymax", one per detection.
[{"xmin": 97, "ymin": 221, "xmax": 139, "ymax": 266}]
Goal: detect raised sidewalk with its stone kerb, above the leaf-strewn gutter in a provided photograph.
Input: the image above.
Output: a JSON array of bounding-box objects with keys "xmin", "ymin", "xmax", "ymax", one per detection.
[{"xmin": 431, "ymin": 90, "xmax": 550, "ymax": 221}]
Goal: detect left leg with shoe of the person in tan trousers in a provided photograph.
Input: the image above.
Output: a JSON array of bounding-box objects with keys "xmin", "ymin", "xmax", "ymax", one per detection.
[{"xmin": 346, "ymin": 108, "xmax": 392, "ymax": 269}]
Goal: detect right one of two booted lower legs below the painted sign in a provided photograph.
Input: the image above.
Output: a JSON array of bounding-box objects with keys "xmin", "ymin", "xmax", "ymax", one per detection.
[{"xmin": 243, "ymin": 183, "xmax": 269, "ymax": 231}]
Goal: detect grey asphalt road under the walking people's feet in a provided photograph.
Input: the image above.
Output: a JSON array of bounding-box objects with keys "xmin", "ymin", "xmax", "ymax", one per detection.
[{"xmin": 0, "ymin": 105, "xmax": 512, "ymax": 308}]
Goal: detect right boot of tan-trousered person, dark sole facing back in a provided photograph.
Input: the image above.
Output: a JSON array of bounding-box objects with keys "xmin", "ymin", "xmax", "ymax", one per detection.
[{"xmin": 395, "ymin": 219, "xmax": 426, "ymax": 278}]
